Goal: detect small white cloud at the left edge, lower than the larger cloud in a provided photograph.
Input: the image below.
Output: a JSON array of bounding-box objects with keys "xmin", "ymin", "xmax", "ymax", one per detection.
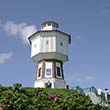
[{"xmin": 0, "ymin": 52, "xmax": 13, "ymax": 64}]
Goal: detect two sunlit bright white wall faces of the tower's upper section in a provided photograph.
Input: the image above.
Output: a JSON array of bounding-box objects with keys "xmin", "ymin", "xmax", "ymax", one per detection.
[{"xmin": 31, "ymin": 37, "xmax": 56, "ymax": 57}]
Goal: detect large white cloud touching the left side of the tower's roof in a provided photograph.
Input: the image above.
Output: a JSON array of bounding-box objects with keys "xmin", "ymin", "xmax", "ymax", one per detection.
[{"xmin": 0, "ymin": 21, "xmax": 37, "ymax": 44}]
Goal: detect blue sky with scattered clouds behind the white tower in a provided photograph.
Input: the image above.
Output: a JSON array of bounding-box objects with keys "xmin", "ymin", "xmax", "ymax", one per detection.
[{"xmin": 0, "ymin": 0, "xmax": 110, "ymax": 89}]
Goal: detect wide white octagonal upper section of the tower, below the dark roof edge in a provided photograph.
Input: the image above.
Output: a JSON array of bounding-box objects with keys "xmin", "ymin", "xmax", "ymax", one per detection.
[{"xmin": 31, "ymin": 32, "xmax": 69, "ymax": 62}]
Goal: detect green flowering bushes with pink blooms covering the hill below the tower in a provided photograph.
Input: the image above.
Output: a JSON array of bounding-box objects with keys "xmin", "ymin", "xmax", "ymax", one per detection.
[{"xmin": 0, "ymin": 83, "xmax": 108, "ymax": 110}]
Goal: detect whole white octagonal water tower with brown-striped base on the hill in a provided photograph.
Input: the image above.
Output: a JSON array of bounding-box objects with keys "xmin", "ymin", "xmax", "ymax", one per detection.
[{"xmin": 29, "ymin": 21, "xmax": 71, "ymax": 88}]
